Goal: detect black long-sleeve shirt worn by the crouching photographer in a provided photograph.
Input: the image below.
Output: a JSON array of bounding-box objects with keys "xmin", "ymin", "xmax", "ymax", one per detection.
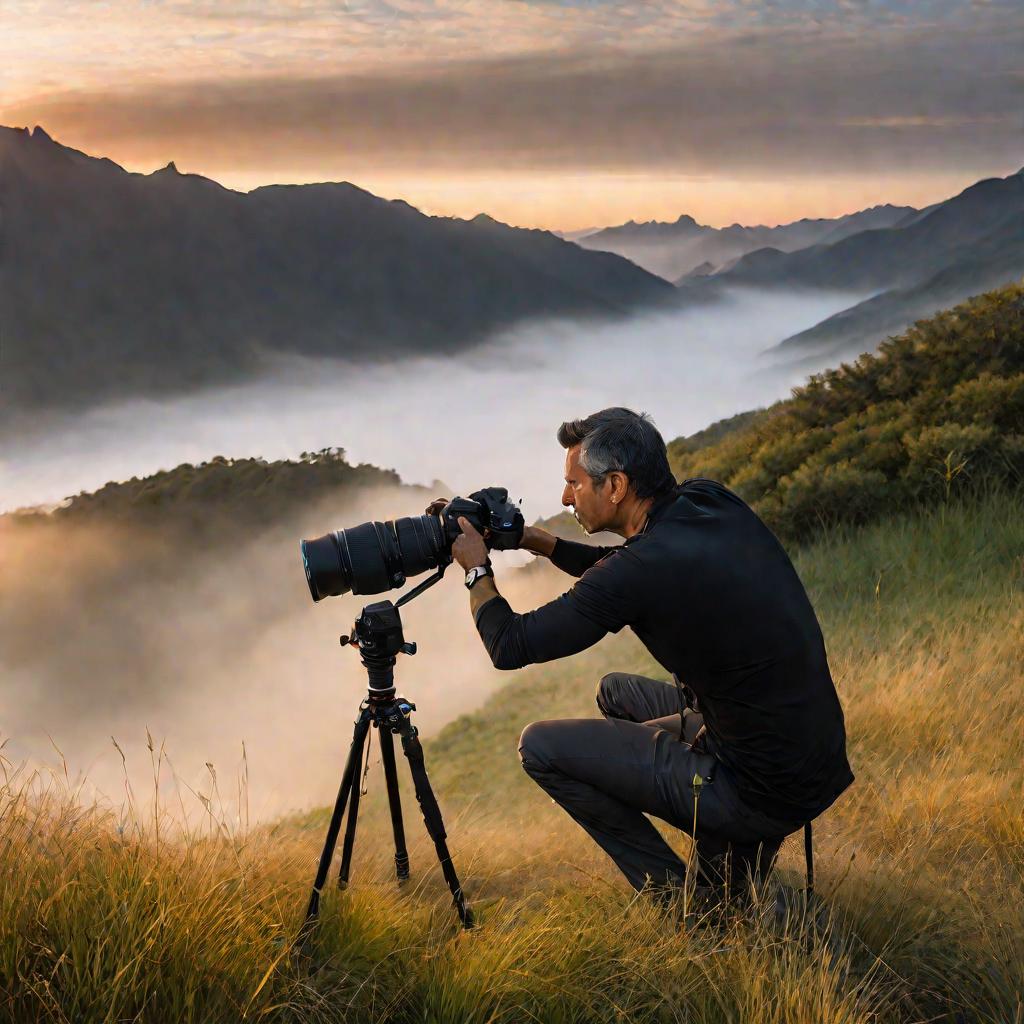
[{"xmin": 476, "ymin": 479, "xmax": 853, "ymax": 820}]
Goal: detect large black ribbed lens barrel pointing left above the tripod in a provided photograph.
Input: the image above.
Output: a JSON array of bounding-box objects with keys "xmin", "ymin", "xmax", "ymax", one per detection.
[{"xmin": 300, "ymin": 515, "xmax": 447, "ymax": 601}]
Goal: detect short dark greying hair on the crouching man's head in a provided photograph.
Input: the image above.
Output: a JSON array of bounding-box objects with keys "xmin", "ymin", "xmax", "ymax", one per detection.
[{"xmin": 558, "ymin": 407, "xmax": 676, "ymax": 498}]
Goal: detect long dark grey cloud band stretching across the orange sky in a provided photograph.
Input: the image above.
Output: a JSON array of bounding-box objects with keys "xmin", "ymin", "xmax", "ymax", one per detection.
[{"xmin": 9, "ymin": 19, "xmax": 1024, "ymax": 178}]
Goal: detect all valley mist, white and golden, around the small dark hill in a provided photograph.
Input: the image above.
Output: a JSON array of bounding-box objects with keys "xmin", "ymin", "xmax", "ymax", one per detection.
[{"xmin": 0, "ymin": 293, "xmax": 864, "ymax": 819}]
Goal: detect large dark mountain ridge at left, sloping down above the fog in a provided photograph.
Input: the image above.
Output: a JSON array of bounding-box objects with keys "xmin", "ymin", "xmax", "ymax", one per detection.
[{"xmin": 0, "ymin": 128, "xmax": 676, "ymax": 411}]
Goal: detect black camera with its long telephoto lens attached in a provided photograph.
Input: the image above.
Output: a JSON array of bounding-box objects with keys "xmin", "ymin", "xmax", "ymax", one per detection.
[{"xmin": 301, "ymin": 487, "xmax": 524, "ymax": 601}]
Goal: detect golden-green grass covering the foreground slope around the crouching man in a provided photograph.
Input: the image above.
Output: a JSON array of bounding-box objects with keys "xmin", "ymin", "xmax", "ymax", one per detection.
[{"xmin": 0, "ymin": 496, "xmax": 1024, "ymax": 1024}]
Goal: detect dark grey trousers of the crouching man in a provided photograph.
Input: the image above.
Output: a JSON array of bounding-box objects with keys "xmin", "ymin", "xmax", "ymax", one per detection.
[{"xmin": 519, "ymin": 672, "xmax": 803, "ymax": 895}]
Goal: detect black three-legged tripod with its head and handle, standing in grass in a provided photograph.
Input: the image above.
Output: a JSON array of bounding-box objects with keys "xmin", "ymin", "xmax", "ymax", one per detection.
[{"xmin": 302, "ymin": 567, "xmax": 473, "ymax": 935}]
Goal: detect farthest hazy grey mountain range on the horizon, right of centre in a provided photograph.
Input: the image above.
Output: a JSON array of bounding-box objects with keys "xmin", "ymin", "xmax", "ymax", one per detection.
[{"xmin": 575, "ymin": 206, "xmax": 915, "ymax": 281}]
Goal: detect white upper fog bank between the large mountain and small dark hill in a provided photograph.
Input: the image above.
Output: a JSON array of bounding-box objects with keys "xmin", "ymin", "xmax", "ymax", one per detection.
[{"xmin": 0, "ymin": 292, "xmax": 860, "ymax": 520}]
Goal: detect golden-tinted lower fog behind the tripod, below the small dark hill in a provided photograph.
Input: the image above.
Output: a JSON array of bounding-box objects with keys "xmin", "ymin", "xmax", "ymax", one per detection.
[{"xmin": 0, "ymin": 489, "xmax": 568, "ymax": 820}]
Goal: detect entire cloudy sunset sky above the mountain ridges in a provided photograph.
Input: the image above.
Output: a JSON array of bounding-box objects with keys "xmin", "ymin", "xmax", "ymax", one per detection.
[{"xmin": 0, "ymin": 0, "xmax": 1024, "ymax": 230}]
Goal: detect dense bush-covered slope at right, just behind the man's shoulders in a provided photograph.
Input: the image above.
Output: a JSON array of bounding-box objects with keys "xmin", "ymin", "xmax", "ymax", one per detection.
[{"xmin": 670, "ymin": 285, "xmax": 1024, "ymax": 540}]
